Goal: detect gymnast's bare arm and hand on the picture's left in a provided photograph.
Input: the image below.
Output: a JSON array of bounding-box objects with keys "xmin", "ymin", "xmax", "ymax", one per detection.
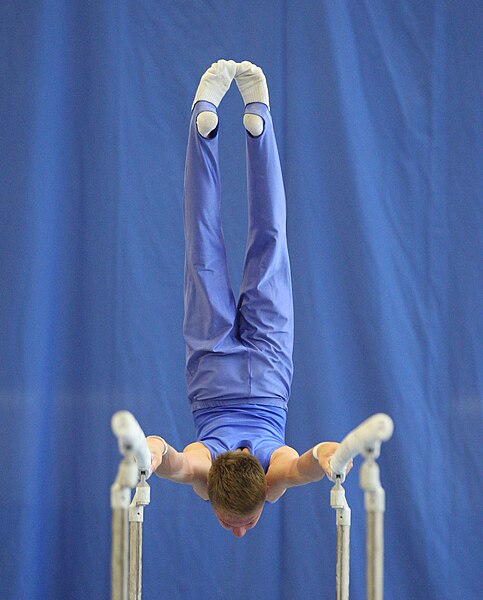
[{"xmin": 146, "ymin": 437, "xmax": 211, "ymax": 500}]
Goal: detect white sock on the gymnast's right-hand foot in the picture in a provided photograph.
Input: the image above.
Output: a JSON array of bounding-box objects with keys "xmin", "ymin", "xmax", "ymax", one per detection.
[{"xmin": 235, "ymin": 60, "xmax": 270, "ymax": 137}]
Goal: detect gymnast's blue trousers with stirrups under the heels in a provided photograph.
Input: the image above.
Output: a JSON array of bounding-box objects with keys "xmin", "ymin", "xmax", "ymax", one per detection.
[{"xmin": 183, "ymin": 101, "xmax": 293, "ymax": 411}]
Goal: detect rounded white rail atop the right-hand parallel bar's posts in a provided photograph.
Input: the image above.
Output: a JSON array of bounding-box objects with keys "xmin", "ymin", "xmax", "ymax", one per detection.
[{"xmin": 330, "ymin": 413, "xmax": 394, "ymax": 476}]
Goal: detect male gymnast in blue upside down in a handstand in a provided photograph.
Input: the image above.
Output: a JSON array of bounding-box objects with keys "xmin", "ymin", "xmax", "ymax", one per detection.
[{"xmin": 147, "ymin": 60, "xmax": 352, "ymax": 538}]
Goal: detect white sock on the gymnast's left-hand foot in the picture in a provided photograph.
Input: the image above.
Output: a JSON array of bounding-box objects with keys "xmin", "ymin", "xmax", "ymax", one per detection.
[{"xmin": 191, "ymin": 59, "xmax": 236, "ymax": 137}]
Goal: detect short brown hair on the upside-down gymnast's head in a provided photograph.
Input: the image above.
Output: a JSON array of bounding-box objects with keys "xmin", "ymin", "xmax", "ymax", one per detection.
[{"xmin": 208, "ymin": 452, "xmax": 267, "ymax": 515}]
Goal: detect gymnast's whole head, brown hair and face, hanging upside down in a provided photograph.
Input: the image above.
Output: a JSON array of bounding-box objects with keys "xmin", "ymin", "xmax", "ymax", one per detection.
[{"xmin": 208, "ymin": 450, "xmax": 267, "ymax": 537}]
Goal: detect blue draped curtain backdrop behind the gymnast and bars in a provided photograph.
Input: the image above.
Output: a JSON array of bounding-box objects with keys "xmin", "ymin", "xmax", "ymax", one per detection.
[{"xmin": 0, "ymin": 0, "xmax": 483, "ymax": 600}]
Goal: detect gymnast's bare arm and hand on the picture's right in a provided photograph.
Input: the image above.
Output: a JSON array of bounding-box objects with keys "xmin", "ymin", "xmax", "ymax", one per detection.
[{"xmin": 267, "ymin": 442, "xmax": 352, "ymax": 502}]
